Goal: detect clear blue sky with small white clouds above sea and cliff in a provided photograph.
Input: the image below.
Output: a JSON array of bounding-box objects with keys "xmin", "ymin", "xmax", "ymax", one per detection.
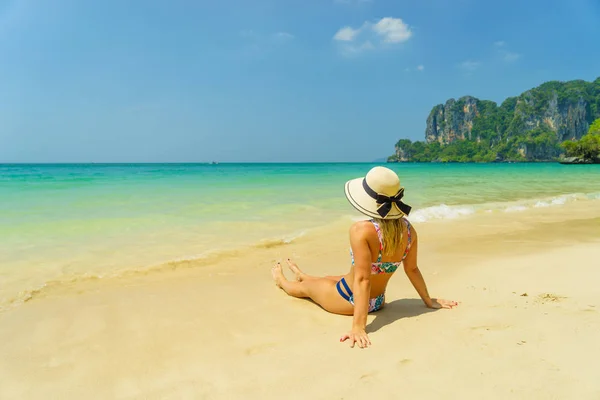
[{"xmin": 0, "ymin": 0, "xmax": 600, "ymax": 162}]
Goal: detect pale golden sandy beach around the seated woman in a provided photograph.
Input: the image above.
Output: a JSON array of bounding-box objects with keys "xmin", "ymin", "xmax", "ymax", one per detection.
[{"xmin": 0, "ymin": 164, "xmax": 600, "ymax": 399}]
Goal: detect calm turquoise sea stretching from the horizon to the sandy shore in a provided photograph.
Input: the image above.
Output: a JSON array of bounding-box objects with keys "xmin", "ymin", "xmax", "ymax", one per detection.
[{"xmin": 0, "ymin": 163, "xmax": 600, "ymax": 307}]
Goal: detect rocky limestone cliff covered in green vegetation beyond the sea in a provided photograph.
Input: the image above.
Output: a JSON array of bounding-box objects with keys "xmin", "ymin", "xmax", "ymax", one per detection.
[{"xmin": 388, "ymin": 78, "xmax": 600, "ymax": 162}]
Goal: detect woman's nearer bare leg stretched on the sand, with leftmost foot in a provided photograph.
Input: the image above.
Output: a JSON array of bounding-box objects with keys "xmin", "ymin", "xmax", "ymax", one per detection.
[{"xmin": 271, "ymin": 263, "xmax": 354, "ymax": 315}]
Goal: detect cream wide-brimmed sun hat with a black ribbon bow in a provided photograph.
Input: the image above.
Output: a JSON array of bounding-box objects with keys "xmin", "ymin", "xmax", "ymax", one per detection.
[{"xmin": 345, "ymin": 167, "xmax": 411, "ymax": 219}]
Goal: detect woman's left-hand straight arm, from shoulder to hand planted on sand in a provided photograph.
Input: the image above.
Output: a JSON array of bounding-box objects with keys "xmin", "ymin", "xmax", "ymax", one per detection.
[{"xmin": 340, "ymin": 224, "xmax": 372, "ymax": 347}]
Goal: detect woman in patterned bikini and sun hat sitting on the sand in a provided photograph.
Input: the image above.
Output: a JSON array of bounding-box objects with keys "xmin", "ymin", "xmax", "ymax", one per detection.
[{"xmin": 272, "ymin": 167, "xmax": 457, "ymax": 348}]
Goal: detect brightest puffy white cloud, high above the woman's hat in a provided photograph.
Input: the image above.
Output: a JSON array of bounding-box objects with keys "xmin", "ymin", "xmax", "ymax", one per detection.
[{"xmin": 333, "ymin": 17, "xmax": 412, "ymax": 55}]
